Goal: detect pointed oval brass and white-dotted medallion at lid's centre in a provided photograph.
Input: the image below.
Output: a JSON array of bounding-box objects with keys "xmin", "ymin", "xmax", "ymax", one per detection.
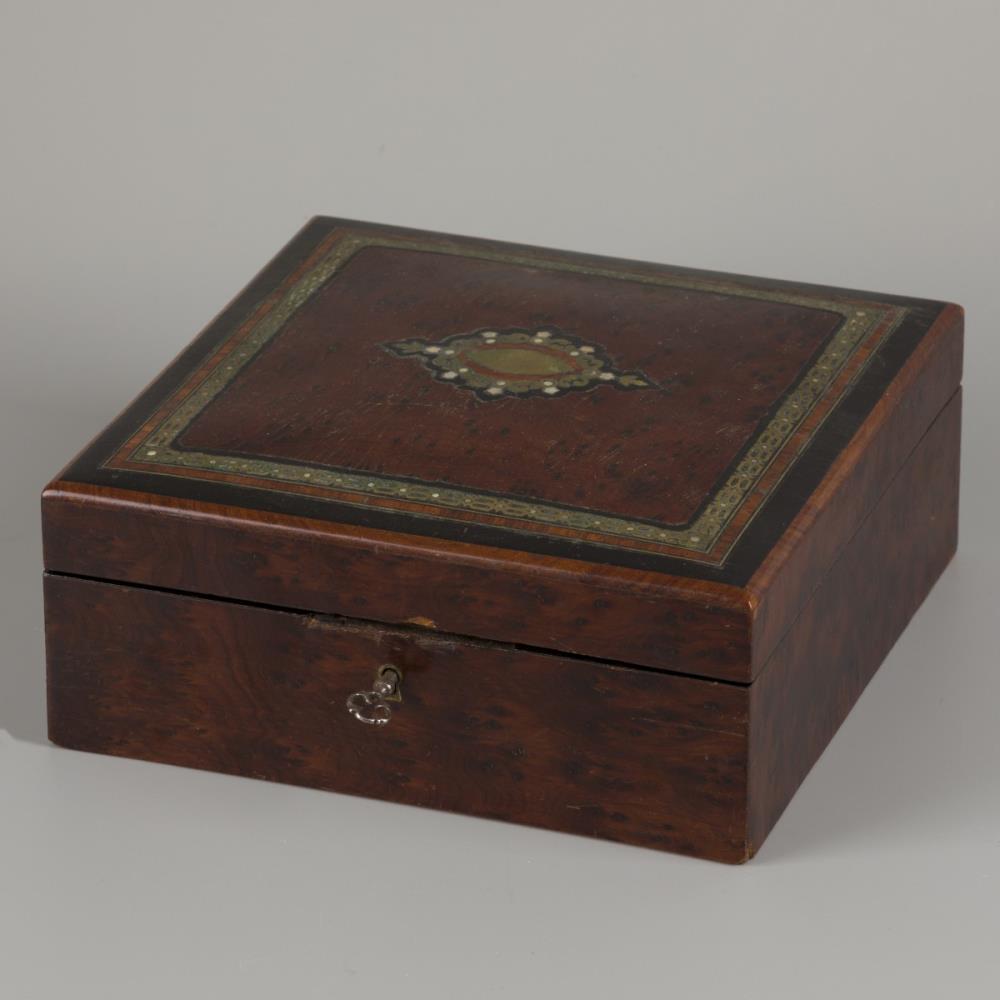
[{"xmin": 382, "ymin": 326, "xmax": 655, "ymax": 399}]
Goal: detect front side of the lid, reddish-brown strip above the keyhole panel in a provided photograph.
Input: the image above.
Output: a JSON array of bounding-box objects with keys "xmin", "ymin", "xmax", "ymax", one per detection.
[{"xmin": 42, "ymin": 484, "xmax": 750, "ymax": 681}]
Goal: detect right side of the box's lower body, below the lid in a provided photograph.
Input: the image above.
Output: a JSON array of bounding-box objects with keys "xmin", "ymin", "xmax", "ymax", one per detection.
[{"xmin": 749, "ymin": 390, "xmax": 961, "ymax": 852}]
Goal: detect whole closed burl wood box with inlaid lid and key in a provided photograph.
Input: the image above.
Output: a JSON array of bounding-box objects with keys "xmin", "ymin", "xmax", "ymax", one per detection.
[{"xmin": 42, "ymin": 218, "xmax": 962, "ymax": 862}]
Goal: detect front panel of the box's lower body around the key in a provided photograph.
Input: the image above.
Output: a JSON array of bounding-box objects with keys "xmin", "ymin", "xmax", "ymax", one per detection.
[{"xmin": 46, "ymin": 575, "xmax": 748, "ymax": 862}]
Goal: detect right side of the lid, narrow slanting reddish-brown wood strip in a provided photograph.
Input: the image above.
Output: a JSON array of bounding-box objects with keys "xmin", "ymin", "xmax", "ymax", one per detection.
[{"xmin": 747, "ymin": 306, "xmax": 963, "ymax": 678}]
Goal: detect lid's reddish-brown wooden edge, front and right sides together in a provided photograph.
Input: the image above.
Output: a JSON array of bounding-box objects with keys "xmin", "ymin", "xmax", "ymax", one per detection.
[{"xmin": 42, "ymin": 300, "xmax": 962, "ymax": 683}]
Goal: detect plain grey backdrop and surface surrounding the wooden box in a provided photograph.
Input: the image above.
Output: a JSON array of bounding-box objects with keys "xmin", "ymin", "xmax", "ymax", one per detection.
[{"xmin": 0, "ymin": 0, "xmax": 1000, "ymax": 1000}]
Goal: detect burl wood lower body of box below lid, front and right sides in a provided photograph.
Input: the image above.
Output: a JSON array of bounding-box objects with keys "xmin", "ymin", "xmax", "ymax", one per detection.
[{"xmin": 46, "ymin": 386, "xmax": 960, "ymax": 862}]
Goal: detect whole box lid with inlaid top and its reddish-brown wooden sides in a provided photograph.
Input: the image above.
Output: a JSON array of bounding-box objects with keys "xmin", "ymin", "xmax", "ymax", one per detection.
[{"xmin": 43, "ymin": 218, "xmax": 962, "ymax": 683}]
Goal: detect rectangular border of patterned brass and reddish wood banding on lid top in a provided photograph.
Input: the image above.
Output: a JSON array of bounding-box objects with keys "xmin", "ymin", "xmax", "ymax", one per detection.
[{"xmin": 103, "ymin": 230, "xmax": 907, "ymax": 565}]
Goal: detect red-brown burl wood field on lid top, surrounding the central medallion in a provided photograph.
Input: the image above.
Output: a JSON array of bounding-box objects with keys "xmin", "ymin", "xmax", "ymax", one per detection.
[{"xmin": 181, "ymin": 247, "xmax": 841, "ymax": 524}]
